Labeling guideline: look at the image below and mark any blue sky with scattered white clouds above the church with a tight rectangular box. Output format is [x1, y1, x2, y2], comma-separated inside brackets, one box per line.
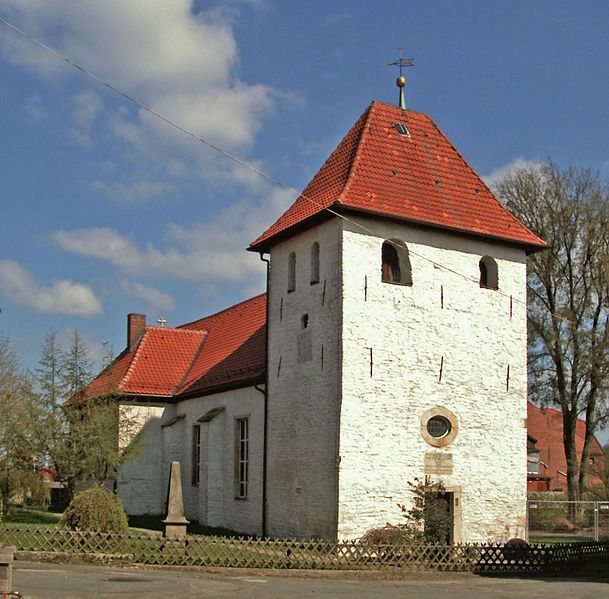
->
[0, 0, 609, 376]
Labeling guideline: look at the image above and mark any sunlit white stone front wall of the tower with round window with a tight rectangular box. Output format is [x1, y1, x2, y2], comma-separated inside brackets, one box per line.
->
[338, 221, 526, 541]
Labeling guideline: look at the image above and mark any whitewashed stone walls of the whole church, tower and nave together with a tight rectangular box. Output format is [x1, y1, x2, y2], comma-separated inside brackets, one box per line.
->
[119, 213, 526, 541]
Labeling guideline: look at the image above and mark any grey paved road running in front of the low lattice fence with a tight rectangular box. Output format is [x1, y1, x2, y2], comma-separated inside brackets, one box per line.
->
[13, 562, 609, 599]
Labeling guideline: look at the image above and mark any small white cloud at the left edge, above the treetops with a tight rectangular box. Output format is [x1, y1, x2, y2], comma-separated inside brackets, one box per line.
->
[0, 260, 102, 316]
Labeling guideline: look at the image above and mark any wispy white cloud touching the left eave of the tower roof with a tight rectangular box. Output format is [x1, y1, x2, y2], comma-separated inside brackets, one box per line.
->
[51, 190, 293, 289]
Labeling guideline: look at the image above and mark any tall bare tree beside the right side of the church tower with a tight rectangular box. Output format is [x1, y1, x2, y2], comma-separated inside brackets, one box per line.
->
[496, 164, 609, 500]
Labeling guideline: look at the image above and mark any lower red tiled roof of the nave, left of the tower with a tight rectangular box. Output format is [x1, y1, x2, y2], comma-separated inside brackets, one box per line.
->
[81, 295, 266, 399]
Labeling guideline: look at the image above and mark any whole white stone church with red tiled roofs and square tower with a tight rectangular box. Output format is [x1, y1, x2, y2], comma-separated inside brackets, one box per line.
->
[85, 94, 545, 542]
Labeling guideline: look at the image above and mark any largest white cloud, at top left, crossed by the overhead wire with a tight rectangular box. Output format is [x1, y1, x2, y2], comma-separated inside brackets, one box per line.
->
[0, 0, 278, 156]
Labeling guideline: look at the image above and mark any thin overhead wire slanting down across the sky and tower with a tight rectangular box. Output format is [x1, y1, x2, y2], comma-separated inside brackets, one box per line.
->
[0, 17, 564, 324]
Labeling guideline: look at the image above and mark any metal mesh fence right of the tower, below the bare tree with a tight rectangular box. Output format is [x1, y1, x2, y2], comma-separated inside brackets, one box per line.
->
[527, 499, 609, 543]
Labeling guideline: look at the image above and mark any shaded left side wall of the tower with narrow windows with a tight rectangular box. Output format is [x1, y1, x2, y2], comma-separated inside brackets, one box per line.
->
[267, 219, 341, 538]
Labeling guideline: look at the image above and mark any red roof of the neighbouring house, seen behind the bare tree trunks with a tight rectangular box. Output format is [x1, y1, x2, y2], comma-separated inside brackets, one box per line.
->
[527, 402, 604, 490]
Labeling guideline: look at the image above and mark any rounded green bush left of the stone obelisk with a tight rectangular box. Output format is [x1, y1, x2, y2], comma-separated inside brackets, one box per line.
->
[62, 487, 129, 533]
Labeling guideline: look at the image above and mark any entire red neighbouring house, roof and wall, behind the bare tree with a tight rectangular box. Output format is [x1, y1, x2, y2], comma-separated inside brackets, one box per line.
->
[527, 402, 604, 492]
